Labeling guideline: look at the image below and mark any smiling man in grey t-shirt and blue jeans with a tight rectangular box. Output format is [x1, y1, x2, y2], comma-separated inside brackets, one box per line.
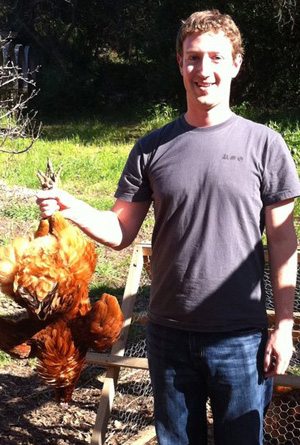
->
[37, 10, 300, 445]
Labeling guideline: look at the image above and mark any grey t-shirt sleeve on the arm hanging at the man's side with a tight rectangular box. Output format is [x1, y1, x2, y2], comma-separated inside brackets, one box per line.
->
[262, 134, 300, 206]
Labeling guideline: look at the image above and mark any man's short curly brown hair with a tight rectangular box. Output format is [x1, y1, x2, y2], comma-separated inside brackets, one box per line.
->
[176, 9, 244, 58]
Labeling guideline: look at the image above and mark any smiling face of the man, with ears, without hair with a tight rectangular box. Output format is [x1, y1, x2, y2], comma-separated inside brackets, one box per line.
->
[177, 31, 242, 110]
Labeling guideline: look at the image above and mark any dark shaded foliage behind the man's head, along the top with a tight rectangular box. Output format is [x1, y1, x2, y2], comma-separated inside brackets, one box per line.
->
[0, 0, 300, 116]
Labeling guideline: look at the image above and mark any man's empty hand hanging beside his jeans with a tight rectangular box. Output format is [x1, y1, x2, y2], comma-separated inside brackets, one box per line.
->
[264, 326, 293, 377]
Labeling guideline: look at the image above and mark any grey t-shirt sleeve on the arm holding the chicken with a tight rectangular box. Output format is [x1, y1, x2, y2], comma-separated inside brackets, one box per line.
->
[115, 141, 152, 202]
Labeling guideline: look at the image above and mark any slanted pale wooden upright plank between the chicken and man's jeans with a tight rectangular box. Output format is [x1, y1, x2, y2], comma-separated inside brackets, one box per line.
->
[91, 245, 143, 445]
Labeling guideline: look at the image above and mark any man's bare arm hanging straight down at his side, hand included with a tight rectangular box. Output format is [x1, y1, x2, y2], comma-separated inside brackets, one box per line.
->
[264, 199, 297, 377]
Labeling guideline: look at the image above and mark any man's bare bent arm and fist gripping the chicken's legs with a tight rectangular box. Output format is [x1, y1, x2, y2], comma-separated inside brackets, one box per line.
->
[36, 189, 151, 250]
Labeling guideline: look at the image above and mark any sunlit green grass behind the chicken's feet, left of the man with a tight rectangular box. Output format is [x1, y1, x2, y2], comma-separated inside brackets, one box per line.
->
[0, 107, 176, 206]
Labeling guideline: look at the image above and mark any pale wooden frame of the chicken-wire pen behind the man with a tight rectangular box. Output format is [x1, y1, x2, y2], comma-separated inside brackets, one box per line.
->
[87, 243, 300, 445]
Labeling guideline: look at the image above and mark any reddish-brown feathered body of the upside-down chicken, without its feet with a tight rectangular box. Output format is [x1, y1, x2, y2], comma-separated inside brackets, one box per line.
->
[0, 170, 123, 402]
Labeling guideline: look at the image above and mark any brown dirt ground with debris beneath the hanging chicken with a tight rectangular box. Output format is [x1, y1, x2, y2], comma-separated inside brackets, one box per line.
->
[0, 361, 106, 445]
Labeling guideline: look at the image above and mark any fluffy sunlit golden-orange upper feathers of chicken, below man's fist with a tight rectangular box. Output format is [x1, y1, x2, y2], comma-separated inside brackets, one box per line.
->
[0, 212, 97, 320]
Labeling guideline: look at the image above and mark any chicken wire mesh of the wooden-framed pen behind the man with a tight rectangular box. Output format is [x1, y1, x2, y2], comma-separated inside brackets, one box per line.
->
[105, 251, 300, 445]
